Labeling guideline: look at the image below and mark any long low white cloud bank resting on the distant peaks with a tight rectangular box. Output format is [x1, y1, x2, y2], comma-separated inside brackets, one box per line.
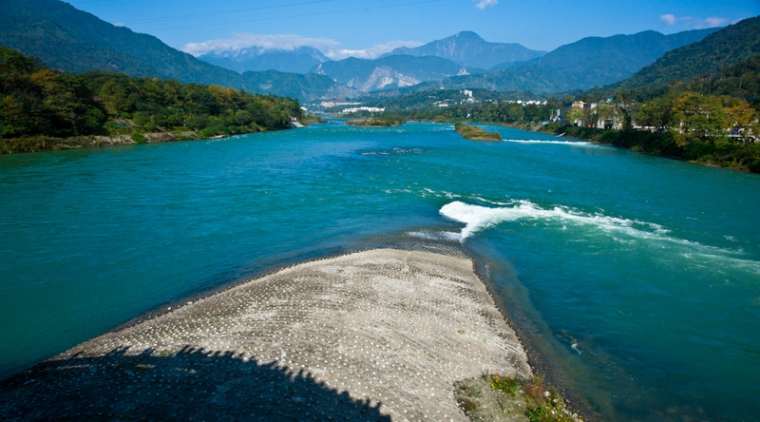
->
[182, 34, 421, 60]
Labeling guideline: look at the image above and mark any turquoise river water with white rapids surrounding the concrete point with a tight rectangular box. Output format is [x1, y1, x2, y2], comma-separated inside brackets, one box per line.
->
[0, 123, 760, 420]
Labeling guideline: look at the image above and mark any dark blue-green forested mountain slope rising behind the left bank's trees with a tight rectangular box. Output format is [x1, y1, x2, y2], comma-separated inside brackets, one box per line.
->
[0, 0, 346, 100]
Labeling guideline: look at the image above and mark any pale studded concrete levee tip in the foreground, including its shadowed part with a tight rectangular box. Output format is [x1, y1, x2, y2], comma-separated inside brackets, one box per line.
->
[0, 249, 530, 421]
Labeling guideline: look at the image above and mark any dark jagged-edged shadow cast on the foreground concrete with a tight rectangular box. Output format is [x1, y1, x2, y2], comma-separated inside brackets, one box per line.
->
[0, 347, 390, 421]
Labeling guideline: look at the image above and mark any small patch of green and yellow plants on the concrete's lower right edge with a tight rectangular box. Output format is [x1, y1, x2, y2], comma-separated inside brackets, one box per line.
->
[454, 375, 583, 422]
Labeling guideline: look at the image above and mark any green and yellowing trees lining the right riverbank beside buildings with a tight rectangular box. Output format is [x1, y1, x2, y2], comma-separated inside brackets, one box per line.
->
[560, 84, 760, 173]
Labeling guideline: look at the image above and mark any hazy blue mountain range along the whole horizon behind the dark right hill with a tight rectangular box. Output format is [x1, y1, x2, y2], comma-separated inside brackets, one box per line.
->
[0, 0, 748, 101]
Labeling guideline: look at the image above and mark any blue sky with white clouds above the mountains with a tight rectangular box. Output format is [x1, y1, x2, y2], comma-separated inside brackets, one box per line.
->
[69, 0, 760, 58]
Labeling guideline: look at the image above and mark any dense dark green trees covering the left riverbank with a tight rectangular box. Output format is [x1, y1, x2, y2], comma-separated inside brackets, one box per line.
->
[0, 47, 302, 153]
